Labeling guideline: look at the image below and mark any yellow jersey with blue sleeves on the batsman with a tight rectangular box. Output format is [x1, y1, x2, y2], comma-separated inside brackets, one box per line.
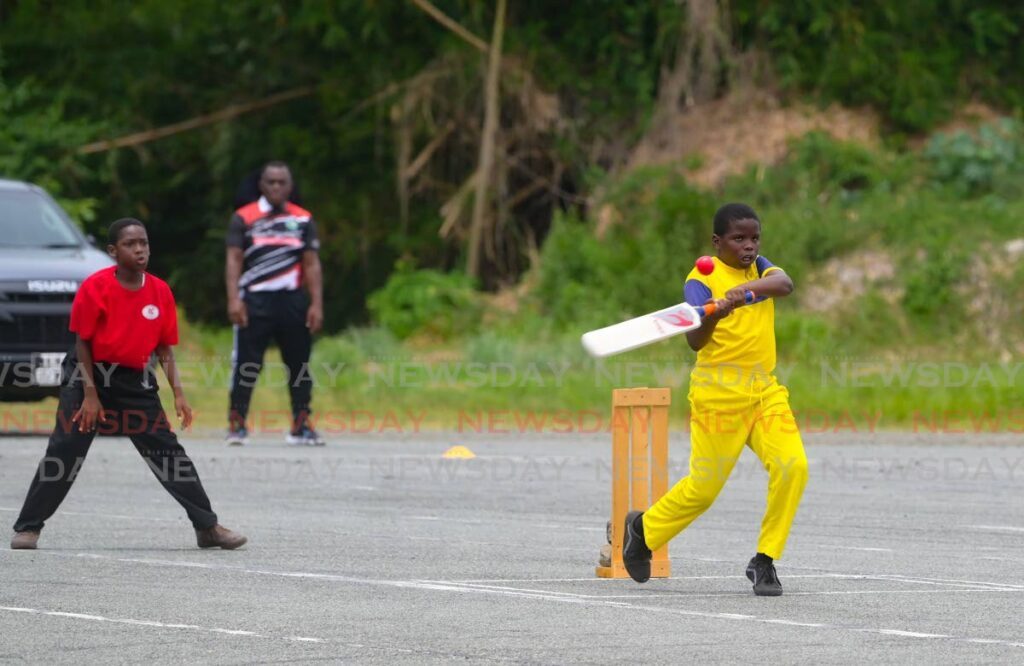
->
[683, 256, 781, 374]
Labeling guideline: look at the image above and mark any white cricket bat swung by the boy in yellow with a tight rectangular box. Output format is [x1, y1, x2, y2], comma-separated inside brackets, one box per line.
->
[582, 291, 756, 358]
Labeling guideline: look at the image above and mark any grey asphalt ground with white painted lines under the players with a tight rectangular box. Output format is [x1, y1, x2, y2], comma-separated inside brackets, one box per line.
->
[0, 433, 1024, 664]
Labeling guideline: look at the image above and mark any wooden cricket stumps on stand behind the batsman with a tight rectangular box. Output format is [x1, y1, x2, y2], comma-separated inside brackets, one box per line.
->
[595, 388, 672, 578]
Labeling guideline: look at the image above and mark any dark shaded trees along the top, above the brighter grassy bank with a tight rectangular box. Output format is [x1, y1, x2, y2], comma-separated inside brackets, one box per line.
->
[0, 0, 1024, 323]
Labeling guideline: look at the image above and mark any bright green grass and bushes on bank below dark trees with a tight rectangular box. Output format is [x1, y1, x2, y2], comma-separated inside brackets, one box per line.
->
[12, 123, 1024, 432]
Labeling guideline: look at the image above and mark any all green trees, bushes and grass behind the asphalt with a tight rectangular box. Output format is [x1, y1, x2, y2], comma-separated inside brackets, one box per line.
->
[0, 0, 1024, 429]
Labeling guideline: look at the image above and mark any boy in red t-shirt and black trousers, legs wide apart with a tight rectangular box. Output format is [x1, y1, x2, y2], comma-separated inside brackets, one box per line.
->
[10, 218, 246, 550]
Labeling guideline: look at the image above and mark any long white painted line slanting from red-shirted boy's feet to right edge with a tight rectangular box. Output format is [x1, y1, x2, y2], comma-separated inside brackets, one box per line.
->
[18, 550, 1024, 648]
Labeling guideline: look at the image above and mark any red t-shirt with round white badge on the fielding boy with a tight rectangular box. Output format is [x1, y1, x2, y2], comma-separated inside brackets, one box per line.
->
[70, 266, 178, 370]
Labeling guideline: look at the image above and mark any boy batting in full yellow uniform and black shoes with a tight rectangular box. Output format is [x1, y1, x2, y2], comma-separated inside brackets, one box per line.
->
[623, 204, 807, 596]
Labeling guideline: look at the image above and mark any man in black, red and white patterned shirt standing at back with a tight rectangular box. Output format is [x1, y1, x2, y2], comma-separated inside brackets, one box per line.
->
[224, 162, 324, 446]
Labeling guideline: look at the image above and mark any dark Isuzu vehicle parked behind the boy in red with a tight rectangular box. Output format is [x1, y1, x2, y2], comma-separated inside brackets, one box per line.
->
[0, 179, 113, 401]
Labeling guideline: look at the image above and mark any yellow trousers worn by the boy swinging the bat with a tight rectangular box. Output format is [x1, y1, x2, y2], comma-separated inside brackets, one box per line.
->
[643, 369, 807, 559]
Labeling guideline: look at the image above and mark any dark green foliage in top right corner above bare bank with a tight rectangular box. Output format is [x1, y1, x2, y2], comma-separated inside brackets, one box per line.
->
[732, 0, 1024, 131]
